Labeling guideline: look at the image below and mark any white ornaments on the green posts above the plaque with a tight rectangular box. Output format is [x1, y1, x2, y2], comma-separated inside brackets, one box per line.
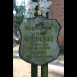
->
[25, 0, 52, 18]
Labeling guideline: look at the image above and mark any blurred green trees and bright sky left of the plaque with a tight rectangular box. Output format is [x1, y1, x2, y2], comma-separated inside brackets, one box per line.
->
[13, 0, 25, 44]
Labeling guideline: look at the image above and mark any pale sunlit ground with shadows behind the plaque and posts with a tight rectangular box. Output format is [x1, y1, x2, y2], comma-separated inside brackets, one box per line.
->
[13, 45, 64, 77]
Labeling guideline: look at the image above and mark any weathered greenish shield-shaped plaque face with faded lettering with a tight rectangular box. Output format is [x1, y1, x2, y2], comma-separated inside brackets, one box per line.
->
[19, 16, 60, 65]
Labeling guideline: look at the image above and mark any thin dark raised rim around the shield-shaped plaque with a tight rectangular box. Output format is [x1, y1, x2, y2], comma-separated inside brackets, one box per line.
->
[18, 16, 61, 65]
